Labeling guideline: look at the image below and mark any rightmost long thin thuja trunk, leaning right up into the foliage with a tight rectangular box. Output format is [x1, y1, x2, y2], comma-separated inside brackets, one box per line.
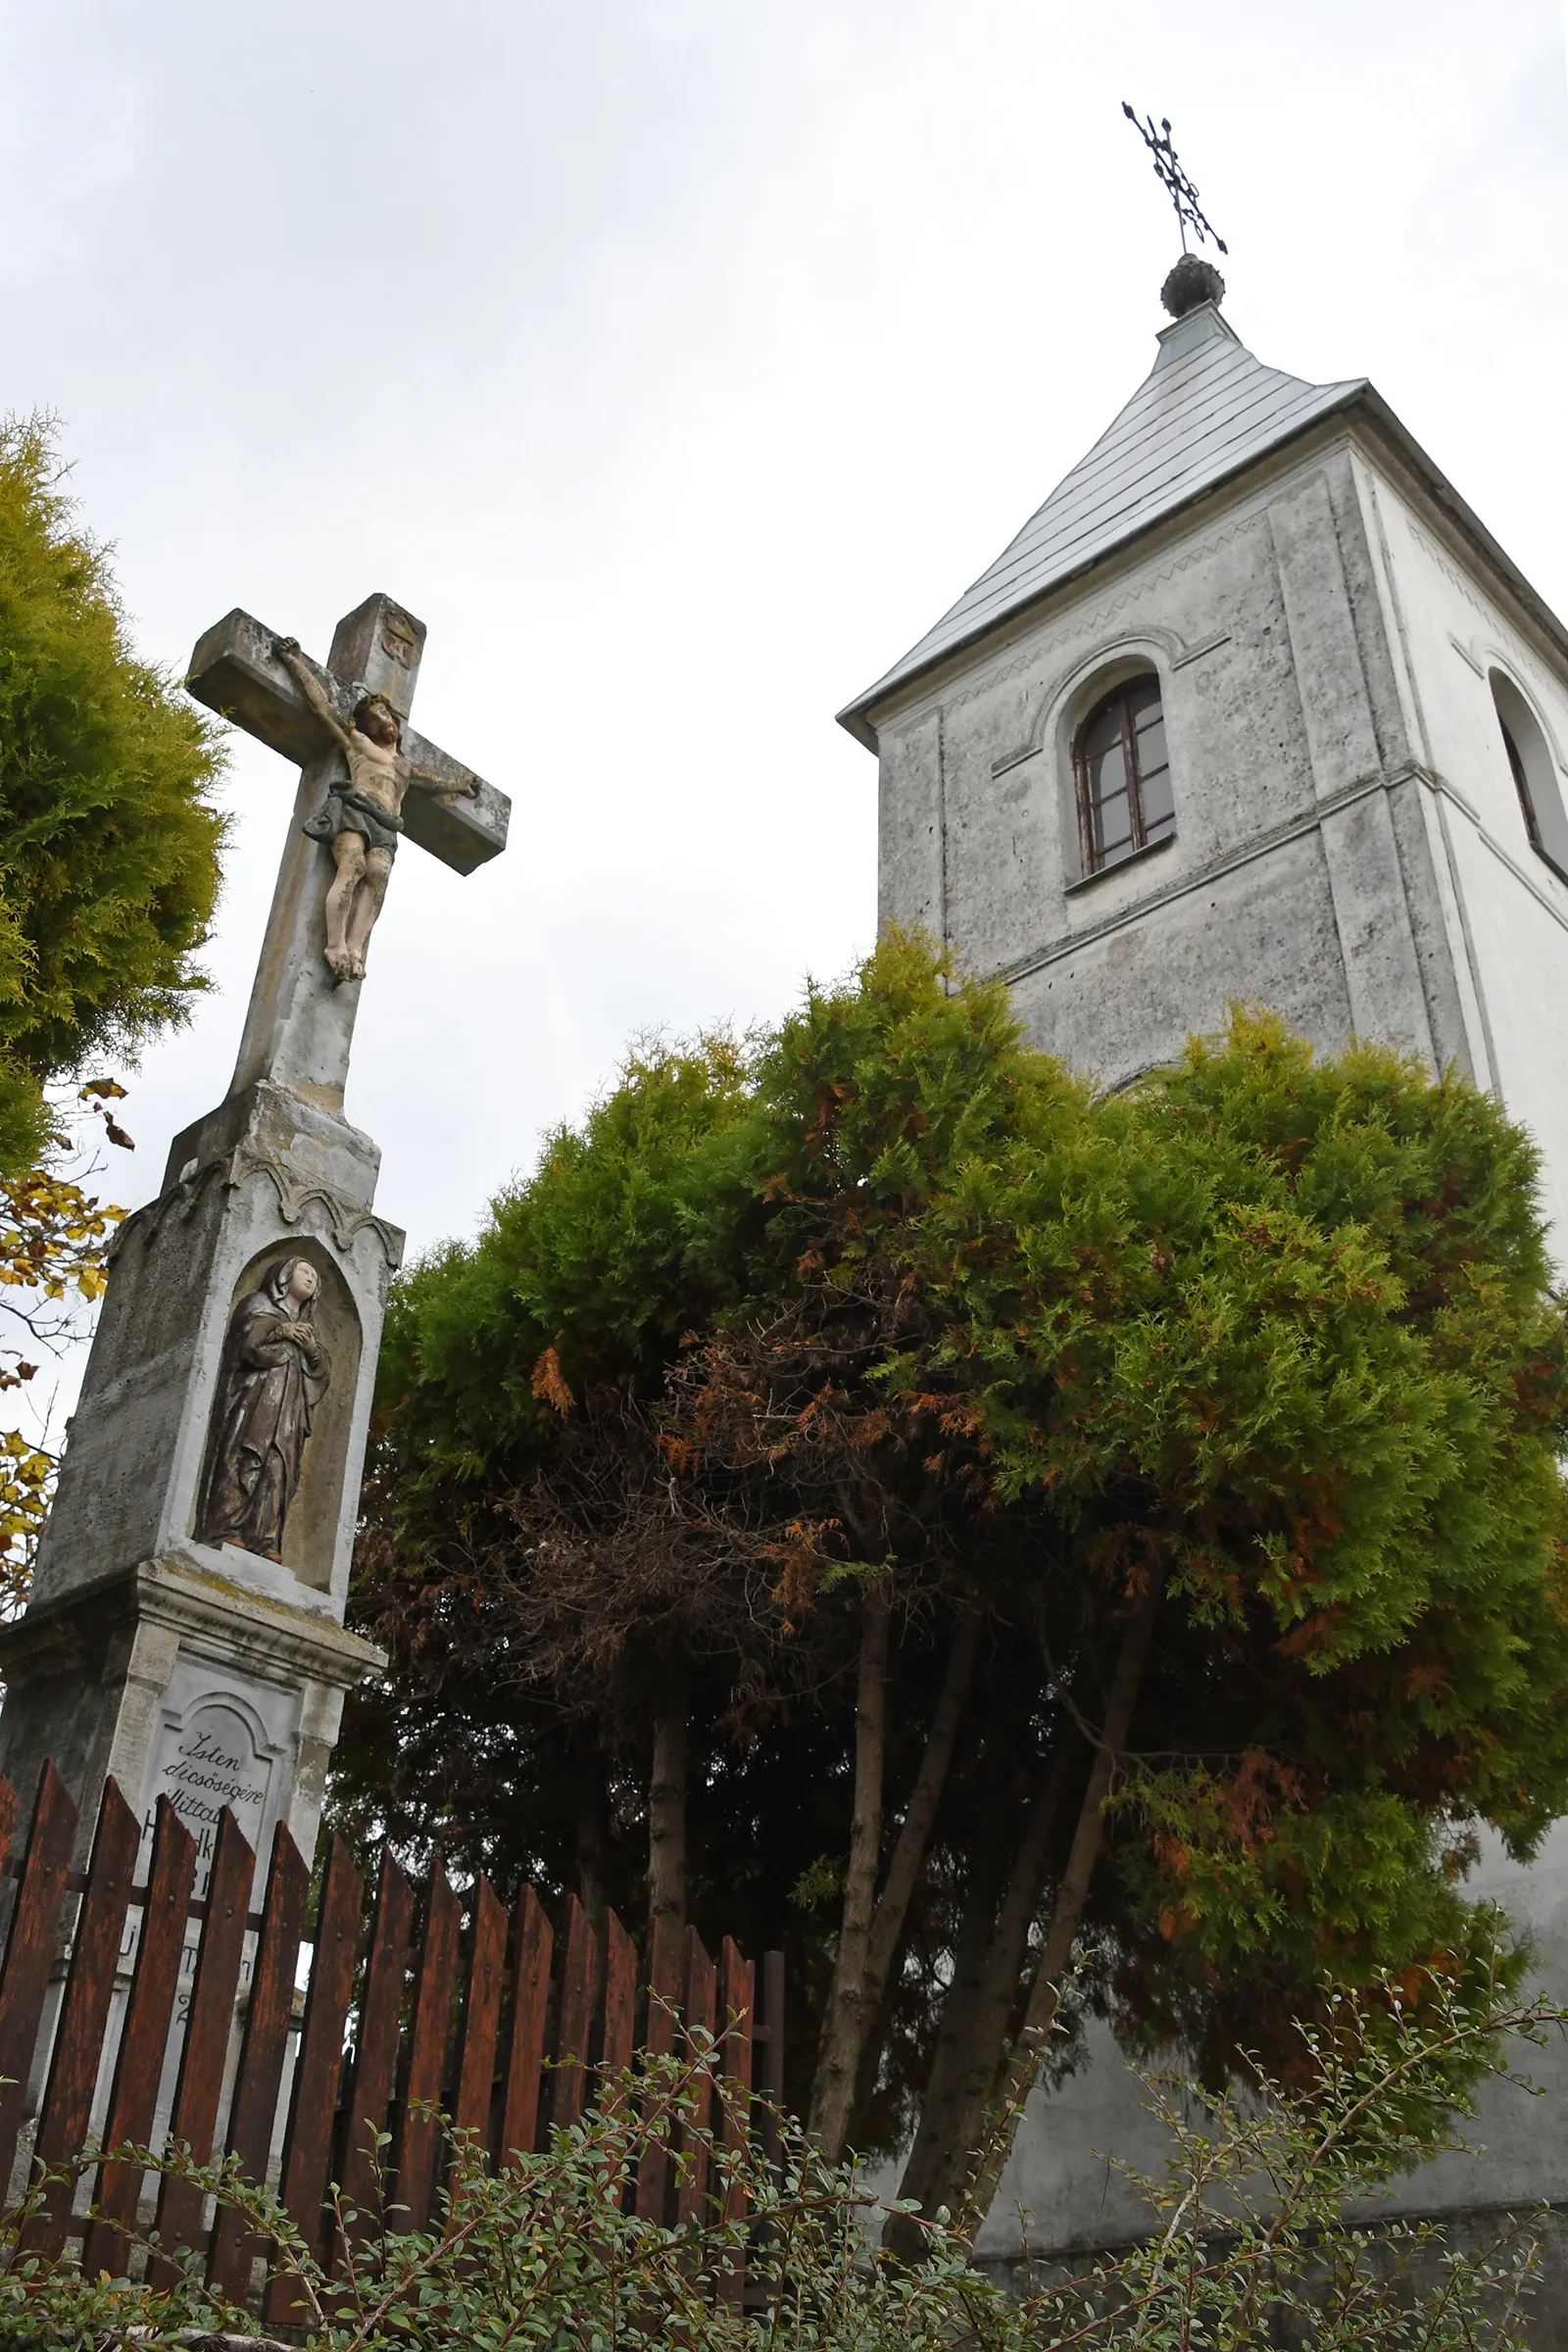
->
[961, 1578, 1159, 2239]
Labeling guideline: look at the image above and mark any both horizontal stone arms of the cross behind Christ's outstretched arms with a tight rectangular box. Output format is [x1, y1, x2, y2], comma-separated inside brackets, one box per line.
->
[186, 612, 513, 875]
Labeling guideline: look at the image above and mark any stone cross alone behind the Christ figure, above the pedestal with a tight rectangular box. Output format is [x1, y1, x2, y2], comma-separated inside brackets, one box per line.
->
[186, 595, 511, 1110]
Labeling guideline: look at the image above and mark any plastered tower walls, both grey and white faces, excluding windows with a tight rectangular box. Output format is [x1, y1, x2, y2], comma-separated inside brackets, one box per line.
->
[872, 404, 1568, 2260]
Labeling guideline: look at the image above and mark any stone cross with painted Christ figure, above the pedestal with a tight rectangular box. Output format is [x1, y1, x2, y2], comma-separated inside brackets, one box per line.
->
[186, 595, 511, 1110]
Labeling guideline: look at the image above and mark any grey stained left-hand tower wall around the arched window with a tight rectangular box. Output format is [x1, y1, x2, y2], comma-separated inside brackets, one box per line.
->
[879, 437, 1504, 1084]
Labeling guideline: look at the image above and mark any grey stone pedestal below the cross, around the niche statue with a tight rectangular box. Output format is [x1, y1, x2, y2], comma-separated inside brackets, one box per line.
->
[0, 1080, 402, 1891]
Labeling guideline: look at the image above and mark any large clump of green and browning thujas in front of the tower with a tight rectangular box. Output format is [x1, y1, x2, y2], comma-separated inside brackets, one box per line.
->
[343, 936, 1568, 2216]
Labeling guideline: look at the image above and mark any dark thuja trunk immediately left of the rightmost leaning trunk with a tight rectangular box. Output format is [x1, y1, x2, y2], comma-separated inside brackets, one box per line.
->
[889, 1736, 1081, 2260]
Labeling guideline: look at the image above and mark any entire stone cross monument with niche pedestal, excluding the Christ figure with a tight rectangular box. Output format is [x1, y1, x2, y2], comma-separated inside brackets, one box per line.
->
[0, 595, 511, 1872]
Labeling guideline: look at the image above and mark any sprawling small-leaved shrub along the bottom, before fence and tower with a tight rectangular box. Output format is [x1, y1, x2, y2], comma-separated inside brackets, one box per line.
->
[0, 1978, 1568, 2352]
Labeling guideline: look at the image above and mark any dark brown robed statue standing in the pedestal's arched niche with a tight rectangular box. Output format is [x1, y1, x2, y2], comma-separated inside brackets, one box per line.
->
[195, 1258, 331, 1559]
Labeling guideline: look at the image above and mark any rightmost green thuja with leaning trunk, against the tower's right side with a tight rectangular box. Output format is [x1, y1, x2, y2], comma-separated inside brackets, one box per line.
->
[883, 1016, 1568, 2238]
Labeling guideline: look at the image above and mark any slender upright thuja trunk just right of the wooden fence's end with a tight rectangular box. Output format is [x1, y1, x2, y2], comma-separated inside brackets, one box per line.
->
[807, 1578, 889, 2159]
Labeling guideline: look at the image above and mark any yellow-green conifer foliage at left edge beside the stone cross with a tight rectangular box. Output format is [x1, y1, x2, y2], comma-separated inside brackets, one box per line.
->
[0, 418, 223, 1174]
